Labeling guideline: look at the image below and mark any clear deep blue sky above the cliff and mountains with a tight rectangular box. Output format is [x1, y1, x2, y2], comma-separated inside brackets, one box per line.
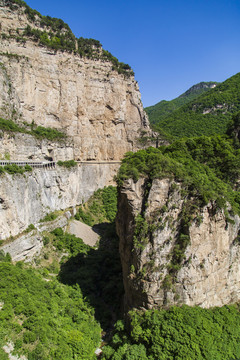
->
[26, 0, 240, 107]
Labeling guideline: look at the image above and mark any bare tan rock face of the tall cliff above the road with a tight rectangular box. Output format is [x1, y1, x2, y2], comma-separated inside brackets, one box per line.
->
[0, 0, 149, 160]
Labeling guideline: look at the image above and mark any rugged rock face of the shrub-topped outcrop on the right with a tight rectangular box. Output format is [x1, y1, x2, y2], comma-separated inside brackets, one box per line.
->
[117, 179, 240, 310]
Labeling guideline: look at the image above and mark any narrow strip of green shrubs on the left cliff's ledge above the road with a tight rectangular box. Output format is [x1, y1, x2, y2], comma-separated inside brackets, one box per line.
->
[0, 118, 66, 140]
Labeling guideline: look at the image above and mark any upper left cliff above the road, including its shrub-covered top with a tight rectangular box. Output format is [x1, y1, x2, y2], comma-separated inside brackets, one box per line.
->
[0, 0, 149, 165]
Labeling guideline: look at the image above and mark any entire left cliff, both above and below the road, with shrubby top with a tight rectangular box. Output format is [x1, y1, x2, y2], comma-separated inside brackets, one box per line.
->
[0, 0, 154, 239]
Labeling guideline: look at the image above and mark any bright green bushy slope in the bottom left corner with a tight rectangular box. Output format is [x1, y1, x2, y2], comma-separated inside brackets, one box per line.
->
[0, 259, 100, 360]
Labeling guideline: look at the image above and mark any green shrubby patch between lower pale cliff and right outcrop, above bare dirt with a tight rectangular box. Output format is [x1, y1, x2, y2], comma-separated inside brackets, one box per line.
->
[75, 186, 117, 226]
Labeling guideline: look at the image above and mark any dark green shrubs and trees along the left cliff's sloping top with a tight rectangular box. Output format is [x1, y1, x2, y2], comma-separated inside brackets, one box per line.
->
[3, 0, 134, 77]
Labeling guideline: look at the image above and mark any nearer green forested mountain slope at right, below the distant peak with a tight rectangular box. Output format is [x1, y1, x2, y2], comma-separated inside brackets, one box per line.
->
[145, 73, 240, 138]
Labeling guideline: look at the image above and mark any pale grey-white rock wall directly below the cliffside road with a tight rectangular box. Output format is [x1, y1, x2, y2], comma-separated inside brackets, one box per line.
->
[0, 164, 119, 239]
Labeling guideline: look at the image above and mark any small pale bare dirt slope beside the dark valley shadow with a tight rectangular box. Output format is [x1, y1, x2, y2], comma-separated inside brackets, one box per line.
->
[68, 220, 99, 246]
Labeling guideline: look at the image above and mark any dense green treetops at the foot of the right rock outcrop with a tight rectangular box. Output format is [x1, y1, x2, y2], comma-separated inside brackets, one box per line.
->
[102, 305, 240, 360]
